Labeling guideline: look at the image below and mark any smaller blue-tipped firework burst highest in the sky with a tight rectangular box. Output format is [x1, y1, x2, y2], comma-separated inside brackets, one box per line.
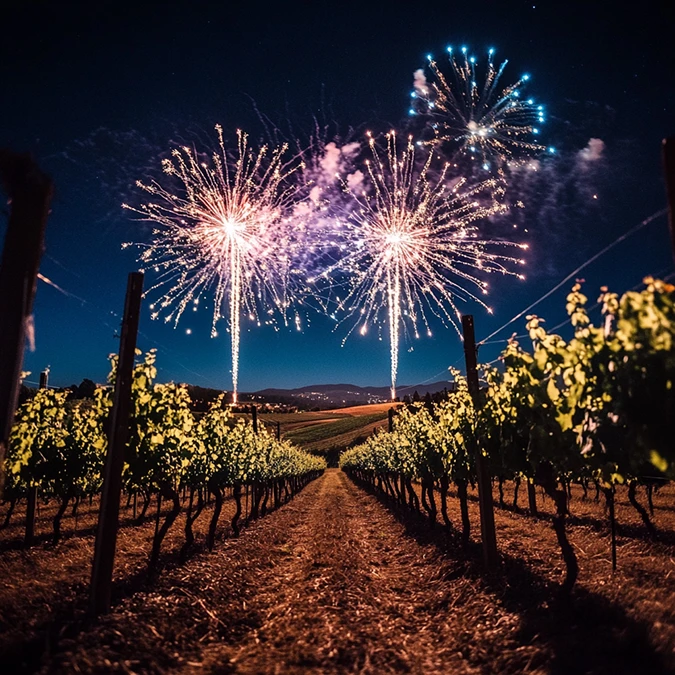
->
[410, 47, 555, 170]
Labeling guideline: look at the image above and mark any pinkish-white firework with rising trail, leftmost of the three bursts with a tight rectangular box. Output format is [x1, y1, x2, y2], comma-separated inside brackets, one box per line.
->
[123, 126, 302, 402]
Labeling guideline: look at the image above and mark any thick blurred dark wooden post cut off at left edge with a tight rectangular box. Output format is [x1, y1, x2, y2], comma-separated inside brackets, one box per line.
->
[0, 150, 54, 496]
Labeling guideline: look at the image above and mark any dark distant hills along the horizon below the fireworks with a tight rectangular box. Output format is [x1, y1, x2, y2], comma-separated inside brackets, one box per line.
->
[251, 381, 454, 408]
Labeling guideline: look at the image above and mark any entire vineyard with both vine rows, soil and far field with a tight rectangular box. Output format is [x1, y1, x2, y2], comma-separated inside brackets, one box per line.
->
[0, 280, 675, 673]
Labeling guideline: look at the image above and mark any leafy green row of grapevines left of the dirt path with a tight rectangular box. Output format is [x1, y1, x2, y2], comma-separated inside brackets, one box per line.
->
[4, 351, 325, 572]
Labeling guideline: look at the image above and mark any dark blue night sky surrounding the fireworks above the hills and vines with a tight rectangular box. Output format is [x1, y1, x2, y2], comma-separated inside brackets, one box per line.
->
[0, 0, 675, 391]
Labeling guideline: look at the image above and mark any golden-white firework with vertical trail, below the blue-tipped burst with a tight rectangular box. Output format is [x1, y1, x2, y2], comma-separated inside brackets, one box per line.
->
[310, 131, 527, 399]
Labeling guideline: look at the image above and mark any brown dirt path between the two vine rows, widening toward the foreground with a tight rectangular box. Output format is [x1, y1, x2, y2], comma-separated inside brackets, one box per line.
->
[42, 470, 672, 675]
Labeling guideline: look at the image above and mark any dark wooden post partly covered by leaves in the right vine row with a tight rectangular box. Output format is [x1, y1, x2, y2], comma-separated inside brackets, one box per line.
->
[462, 314, 498, 570]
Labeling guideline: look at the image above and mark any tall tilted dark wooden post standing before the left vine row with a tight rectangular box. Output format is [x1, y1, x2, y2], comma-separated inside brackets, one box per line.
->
[90, 272, 143, 614]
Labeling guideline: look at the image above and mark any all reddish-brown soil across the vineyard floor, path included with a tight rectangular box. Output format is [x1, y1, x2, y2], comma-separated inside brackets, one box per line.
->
[0, 469, 675, 674]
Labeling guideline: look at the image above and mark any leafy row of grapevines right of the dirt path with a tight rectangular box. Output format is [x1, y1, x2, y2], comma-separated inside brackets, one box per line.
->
[341, 279, 675, 590]
